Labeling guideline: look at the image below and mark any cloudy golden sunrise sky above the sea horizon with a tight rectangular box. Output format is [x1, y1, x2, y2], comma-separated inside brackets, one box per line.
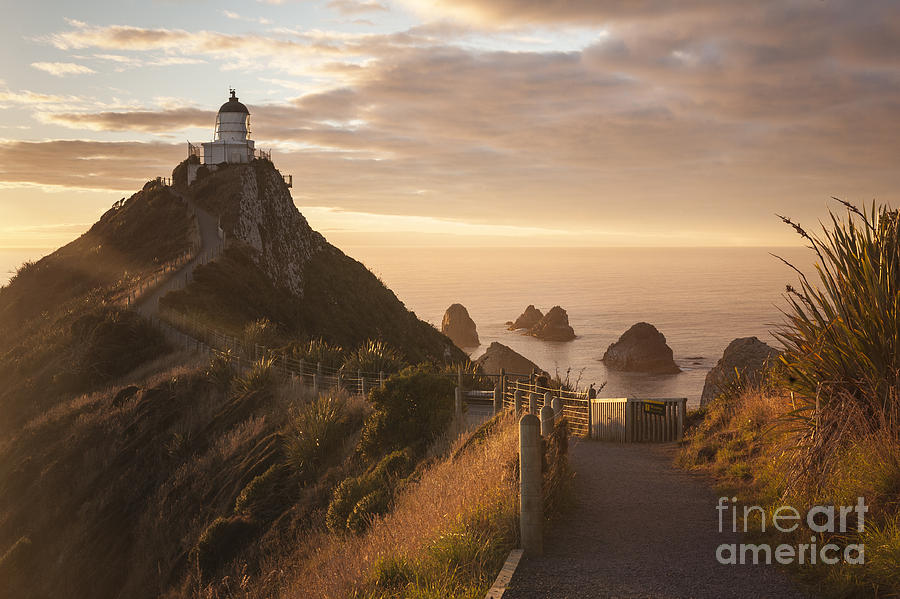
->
[0, 0, 900, 247]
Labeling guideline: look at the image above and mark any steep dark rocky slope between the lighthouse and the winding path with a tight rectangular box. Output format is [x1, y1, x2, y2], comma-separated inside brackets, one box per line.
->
[162, 160, 463, 362]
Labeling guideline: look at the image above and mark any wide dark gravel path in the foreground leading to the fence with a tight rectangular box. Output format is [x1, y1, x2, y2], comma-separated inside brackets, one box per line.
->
[503, 441, 806, 599]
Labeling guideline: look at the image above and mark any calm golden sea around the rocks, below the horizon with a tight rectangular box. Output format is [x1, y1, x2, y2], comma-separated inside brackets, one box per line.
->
[0, 246, 812, 405]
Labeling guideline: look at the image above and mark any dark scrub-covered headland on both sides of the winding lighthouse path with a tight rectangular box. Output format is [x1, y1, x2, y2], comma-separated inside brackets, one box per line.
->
[0, 161, 472, 597]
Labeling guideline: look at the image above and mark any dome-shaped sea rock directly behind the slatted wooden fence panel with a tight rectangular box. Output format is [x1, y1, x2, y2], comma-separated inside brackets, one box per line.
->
[602, 322, 681, 374]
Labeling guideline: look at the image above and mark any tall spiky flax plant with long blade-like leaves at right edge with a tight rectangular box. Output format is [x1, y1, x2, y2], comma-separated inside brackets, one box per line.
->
[775, 198, 900, 411]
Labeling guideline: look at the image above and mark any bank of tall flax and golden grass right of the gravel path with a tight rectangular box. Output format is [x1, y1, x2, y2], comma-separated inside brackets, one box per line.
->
[680, 204, 900, 597]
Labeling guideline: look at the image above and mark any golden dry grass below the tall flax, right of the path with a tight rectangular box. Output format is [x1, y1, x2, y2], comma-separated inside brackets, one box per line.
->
[678, 389, 900, 597]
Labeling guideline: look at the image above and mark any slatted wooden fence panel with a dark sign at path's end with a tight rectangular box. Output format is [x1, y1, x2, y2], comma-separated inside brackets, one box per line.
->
[591, 398, 687, 443]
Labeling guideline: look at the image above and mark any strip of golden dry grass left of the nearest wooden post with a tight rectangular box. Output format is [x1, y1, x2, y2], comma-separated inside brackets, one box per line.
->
[281, 416, 517, 598]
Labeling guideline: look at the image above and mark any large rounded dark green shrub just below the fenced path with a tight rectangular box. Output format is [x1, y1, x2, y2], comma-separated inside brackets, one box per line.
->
[359, 366, 453, 459]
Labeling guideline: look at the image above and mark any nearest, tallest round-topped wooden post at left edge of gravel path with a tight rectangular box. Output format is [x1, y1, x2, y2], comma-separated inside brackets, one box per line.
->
[519, 414, 544, 556]
